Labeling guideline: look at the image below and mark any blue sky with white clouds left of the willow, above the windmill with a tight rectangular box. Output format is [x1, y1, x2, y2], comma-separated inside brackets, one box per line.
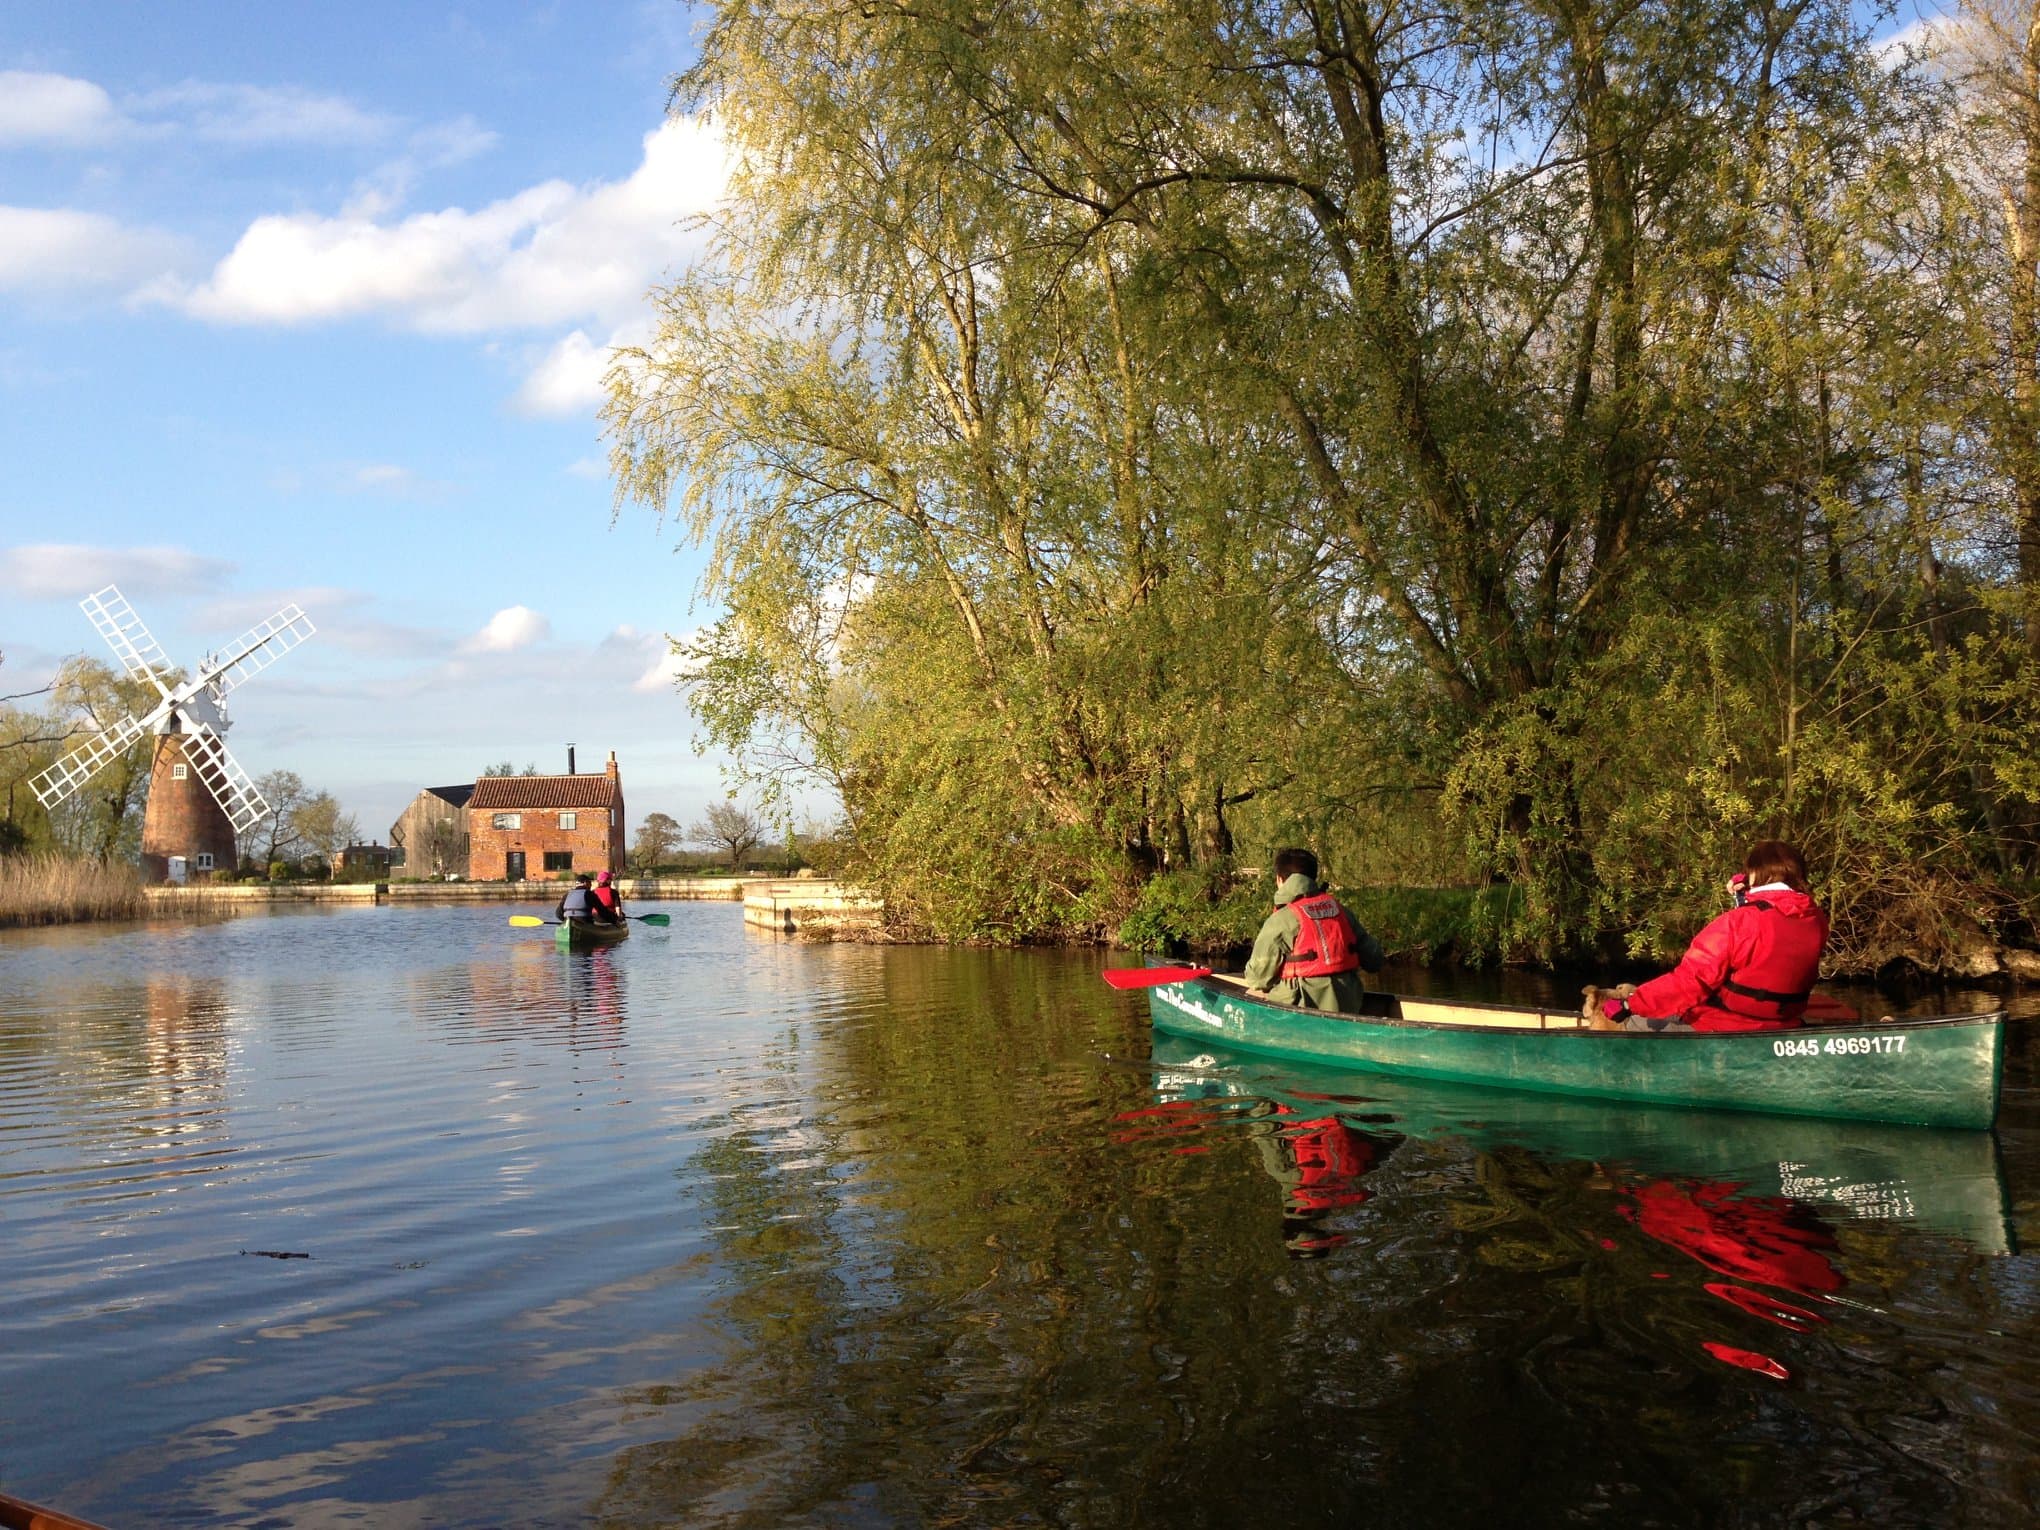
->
[0, 0, 742, 834]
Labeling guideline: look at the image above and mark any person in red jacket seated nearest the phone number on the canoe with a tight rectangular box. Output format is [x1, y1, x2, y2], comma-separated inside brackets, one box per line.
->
[1599, 838, 1828, 1030]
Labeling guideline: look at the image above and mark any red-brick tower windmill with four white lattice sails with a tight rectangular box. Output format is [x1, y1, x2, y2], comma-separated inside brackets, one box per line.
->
[29, 585, 316, 881]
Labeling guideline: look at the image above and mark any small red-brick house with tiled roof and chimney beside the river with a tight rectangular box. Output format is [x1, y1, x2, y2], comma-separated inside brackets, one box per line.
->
[467, 749, 624, 881]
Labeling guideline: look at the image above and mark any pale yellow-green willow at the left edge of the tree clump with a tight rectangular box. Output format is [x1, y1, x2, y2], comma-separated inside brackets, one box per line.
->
[608, 14, 1371, 936]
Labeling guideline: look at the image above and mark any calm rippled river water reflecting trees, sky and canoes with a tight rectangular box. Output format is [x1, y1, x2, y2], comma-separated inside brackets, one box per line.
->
[0, 904, 2040, 1528]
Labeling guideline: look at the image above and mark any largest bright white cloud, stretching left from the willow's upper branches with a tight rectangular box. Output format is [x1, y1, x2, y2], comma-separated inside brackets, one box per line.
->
[184, 118, 726, 334]
